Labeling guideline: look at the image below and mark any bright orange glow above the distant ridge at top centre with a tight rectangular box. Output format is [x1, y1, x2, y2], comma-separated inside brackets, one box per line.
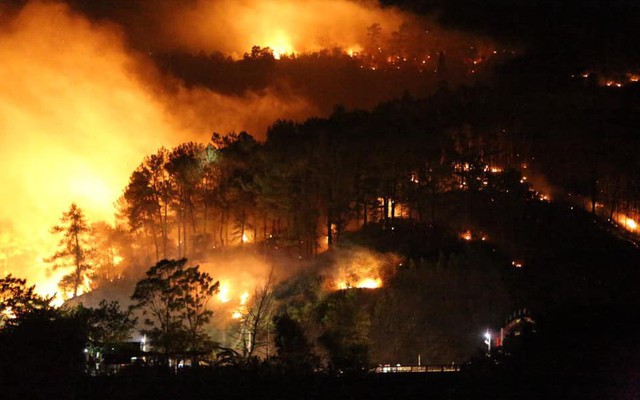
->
[158, 0, 411, 59]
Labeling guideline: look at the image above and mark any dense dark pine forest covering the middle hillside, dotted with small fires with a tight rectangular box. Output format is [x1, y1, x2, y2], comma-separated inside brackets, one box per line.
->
[11, 70, 638, 367]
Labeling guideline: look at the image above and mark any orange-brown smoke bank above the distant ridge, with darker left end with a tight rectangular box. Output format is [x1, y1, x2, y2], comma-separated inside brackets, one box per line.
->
[63, 0, 404, 58]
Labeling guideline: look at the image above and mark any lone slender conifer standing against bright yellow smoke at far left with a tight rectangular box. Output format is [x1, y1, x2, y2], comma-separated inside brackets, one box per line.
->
[45, 203, 93, 298]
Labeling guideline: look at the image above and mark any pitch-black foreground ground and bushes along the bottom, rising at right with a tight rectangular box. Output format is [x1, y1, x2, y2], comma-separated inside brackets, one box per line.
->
[5, 304, 640, 400]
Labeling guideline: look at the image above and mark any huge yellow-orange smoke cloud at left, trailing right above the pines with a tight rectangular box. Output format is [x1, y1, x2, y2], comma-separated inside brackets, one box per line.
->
[0, 1, 316, 291]
